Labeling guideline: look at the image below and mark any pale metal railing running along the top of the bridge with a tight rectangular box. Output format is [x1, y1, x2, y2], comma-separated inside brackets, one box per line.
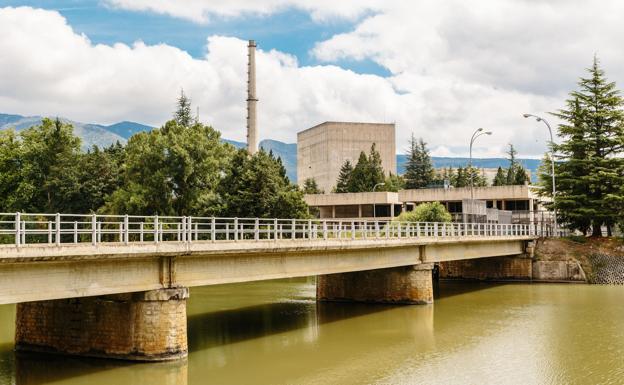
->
[0, 213, 535, 247]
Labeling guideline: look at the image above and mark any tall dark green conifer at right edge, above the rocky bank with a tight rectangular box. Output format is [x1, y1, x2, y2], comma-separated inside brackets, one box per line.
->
[543, 57, 624, 236]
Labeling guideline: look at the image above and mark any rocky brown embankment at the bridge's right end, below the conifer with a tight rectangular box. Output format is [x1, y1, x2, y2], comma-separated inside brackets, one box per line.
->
[533, 237, 624, 285]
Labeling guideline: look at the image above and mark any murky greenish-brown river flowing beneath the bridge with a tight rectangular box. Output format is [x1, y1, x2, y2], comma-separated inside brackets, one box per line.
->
[0, 278, 624, 385]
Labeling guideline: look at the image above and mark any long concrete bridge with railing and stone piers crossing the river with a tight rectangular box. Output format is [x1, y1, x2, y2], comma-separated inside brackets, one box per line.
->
[0, 213, 536, 360]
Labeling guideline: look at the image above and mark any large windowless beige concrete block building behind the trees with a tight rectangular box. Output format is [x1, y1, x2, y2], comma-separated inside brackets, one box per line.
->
[297, 122, 397, 193]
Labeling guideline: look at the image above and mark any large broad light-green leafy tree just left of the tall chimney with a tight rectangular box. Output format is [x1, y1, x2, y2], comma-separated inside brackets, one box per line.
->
[103, 120, 234, 216]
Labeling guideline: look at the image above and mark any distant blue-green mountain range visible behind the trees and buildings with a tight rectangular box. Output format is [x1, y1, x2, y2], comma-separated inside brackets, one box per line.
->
[0, 113, 540, 182]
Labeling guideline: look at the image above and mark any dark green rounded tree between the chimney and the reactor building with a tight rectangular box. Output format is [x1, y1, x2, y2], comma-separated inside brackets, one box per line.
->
[219, 149, 308, 218]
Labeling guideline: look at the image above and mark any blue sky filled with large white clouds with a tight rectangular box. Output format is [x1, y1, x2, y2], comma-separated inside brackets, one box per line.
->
[0, 0, 624, 157]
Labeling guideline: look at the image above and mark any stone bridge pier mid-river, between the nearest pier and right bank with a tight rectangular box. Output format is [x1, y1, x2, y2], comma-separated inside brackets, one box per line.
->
[316, 263, 433, 304]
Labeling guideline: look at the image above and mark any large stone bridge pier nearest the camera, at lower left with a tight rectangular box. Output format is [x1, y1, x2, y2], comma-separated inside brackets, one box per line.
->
[15, 287, 188, 361]
